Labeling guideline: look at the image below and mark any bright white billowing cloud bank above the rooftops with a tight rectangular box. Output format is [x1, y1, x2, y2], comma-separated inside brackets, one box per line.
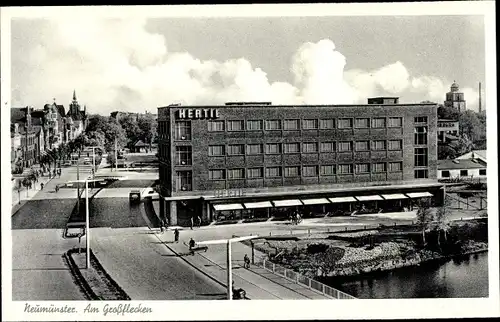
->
[13, 16, 477, 114]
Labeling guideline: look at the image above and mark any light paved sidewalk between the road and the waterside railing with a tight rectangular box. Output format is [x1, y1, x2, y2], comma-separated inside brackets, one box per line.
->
[156, 234, 329, 300]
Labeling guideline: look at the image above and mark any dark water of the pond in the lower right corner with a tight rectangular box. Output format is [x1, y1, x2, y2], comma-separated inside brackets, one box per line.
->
[331, 252, 488, 299]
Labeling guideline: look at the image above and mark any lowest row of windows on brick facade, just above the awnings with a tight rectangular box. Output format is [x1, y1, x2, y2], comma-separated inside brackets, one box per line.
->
[208, 161, 403, 180]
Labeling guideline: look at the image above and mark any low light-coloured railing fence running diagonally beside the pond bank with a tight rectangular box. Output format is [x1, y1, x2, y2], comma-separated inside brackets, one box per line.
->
[255, 259, 356, 300]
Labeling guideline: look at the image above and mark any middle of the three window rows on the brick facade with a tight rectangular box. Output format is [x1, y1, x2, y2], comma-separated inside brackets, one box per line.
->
[208, 140, 403, 156]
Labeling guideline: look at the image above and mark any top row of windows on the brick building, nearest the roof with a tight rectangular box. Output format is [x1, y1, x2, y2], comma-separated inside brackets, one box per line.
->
[208, 117, 403, 132]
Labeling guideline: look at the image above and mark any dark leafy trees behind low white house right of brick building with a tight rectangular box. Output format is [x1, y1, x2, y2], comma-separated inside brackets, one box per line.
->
[437, 105, 486, 160]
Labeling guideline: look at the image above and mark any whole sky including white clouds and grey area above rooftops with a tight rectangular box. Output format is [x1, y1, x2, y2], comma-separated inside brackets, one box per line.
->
[11, 15, 485, 115]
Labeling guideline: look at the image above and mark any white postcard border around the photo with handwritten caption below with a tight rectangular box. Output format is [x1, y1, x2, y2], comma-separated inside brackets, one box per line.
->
[1, 1, 500, 321]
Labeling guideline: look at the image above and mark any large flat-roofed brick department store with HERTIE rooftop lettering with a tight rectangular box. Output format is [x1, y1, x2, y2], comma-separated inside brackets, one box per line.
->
[158, 98, 444, 225]
